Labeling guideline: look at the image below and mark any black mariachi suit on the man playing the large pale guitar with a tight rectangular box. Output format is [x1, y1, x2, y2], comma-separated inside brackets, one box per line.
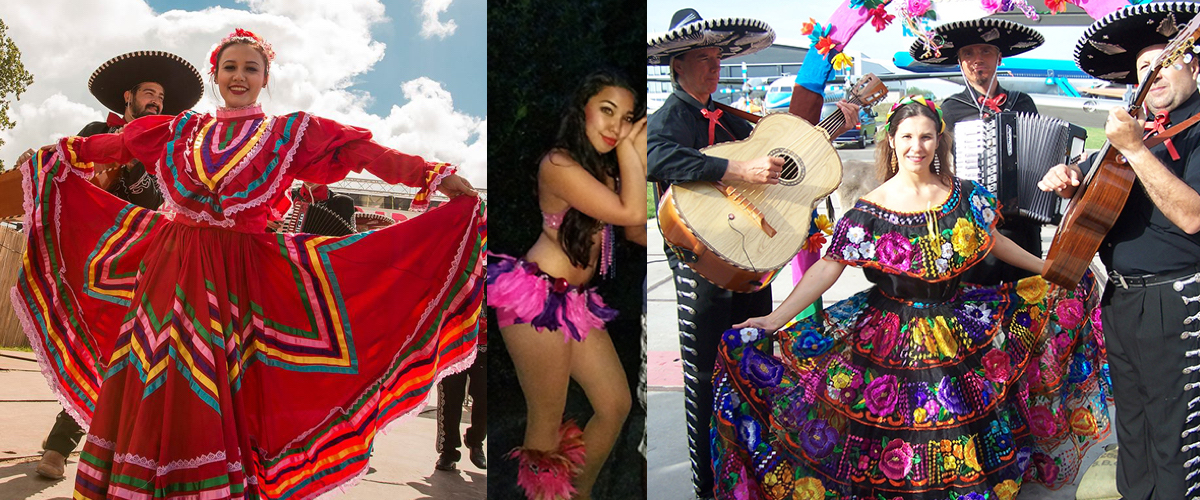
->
[647, 90, 772, 498]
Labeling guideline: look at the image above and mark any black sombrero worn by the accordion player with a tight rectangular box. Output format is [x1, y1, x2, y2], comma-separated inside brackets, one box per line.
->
[908, 19, 1045, 66]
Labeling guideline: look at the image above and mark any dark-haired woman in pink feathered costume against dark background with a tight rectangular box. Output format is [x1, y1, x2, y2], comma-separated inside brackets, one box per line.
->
[487, 71, 646, 500]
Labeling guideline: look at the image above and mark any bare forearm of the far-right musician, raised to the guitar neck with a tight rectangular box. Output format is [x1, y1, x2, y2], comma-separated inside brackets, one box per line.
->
[1104, 108, 1200, 234]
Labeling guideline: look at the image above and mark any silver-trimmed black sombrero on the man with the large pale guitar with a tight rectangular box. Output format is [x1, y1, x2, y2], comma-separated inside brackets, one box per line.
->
[646, 8, 775, 65]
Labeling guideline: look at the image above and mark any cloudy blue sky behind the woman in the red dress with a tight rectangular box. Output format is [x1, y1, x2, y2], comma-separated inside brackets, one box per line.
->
[0, 0, 487, 187]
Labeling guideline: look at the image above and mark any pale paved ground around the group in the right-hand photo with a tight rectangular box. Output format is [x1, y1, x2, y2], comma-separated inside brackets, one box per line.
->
[646, 143, 1116, 500]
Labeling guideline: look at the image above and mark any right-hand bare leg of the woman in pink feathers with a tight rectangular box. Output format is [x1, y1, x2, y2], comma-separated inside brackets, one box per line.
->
[570, 330, 631, 500]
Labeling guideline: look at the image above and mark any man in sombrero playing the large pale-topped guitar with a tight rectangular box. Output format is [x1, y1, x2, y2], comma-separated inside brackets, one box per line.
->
[647, 8, 858, 499]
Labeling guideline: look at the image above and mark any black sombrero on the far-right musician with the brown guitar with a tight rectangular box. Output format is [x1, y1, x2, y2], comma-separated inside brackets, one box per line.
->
[1075, 1, 1200, 84]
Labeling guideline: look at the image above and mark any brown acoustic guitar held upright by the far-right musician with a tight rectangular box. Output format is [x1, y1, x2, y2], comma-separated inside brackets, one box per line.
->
[1042, 16, 1200, 289]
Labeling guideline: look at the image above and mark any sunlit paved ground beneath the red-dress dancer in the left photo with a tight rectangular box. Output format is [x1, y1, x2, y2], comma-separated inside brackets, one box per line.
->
[0, 350, 487, 500]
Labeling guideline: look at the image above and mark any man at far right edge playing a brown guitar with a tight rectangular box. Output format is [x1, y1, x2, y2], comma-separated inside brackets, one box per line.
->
[1038, 2, 1200, 500]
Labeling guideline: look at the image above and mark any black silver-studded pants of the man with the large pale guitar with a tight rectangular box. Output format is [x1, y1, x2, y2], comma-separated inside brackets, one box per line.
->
[667, 256, 772, 498]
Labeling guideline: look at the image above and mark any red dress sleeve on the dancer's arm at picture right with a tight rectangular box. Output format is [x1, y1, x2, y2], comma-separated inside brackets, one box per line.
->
[295, 115, 457, 211]
